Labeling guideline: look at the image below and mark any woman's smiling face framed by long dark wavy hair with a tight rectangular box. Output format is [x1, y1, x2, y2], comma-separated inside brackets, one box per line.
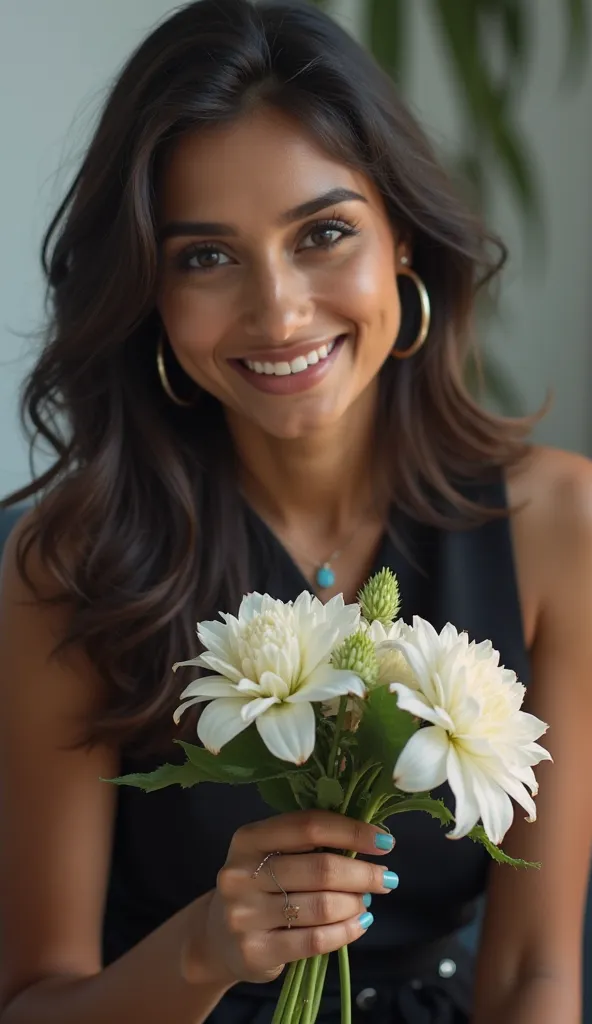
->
[158, 110, 407, 438]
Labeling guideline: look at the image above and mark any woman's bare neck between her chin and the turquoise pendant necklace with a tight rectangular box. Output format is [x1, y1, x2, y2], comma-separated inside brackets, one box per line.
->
[228, 387, 381, 538]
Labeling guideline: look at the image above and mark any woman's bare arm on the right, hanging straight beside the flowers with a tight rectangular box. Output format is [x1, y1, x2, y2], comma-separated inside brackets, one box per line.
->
[474, 450, 592, 1024]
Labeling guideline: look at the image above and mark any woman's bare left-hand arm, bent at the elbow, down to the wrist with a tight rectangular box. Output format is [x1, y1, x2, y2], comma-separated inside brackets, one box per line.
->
[0, 537, 230, 1024]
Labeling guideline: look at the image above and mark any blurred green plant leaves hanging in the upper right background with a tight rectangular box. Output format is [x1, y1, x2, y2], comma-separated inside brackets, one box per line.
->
[311, 0, 592, 415]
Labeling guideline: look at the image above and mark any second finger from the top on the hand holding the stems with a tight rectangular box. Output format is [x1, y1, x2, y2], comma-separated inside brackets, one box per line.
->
[250, 853, 393, 896]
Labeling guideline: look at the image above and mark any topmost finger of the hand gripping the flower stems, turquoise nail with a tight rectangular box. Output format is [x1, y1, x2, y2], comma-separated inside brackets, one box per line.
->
[229, 810, 394, 862]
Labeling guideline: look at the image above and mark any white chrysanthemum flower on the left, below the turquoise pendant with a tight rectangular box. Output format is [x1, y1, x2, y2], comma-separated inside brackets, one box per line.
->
[174, 592, 366, 764]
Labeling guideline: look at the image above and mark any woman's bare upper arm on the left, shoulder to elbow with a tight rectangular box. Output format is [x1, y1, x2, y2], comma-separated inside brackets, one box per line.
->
[0, 513, 118, 1012]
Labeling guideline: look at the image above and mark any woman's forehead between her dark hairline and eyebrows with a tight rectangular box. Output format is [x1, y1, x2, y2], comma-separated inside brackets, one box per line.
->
[159, 110, 381, 223]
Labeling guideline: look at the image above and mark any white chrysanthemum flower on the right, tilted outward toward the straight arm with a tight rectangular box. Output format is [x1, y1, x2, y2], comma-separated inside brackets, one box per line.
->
[390, 616, 551, 844]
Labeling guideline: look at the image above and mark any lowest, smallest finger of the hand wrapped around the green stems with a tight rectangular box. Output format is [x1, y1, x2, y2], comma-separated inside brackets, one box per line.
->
[263, 910, 374, 966]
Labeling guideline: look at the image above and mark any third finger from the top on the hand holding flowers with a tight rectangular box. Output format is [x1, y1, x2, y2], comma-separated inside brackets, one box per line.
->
[241, 892, 370, 932]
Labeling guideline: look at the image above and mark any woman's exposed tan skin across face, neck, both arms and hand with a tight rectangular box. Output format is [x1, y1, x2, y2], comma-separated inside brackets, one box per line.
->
[0, 112, 592, 1024]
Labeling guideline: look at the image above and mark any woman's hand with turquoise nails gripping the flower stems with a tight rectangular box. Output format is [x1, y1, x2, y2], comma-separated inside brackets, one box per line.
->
[204, 811, 398, 982]
